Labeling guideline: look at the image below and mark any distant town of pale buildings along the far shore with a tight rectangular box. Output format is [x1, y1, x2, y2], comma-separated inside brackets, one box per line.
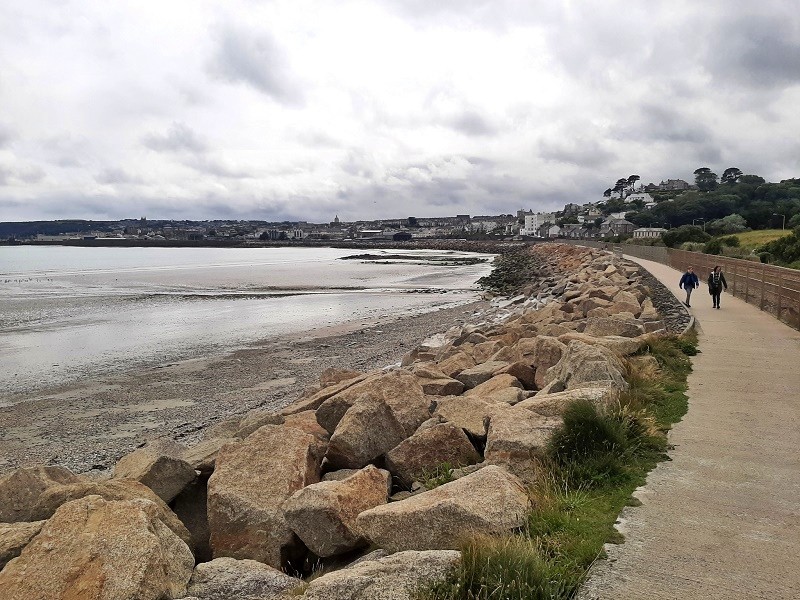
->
[0, 180, 692, 243]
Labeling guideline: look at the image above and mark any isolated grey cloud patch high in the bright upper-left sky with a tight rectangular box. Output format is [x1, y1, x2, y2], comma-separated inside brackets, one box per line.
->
[208, 27, 302, 105]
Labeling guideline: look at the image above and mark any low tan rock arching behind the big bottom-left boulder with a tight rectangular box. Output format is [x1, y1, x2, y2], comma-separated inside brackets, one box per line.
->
[31, 479, 192, 548]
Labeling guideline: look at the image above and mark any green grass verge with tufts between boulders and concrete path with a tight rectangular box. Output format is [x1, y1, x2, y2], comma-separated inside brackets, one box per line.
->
[418, 332, 697, 600]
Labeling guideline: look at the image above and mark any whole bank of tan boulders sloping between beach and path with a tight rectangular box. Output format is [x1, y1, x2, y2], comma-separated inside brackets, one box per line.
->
[0, 244, 689, 600]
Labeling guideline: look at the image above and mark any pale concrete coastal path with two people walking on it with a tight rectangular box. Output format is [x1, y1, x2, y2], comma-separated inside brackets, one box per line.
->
[579, 257, 800, 600]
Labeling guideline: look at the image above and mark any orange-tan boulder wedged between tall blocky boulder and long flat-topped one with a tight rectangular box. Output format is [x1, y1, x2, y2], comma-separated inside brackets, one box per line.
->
[283, 465, 389, 558]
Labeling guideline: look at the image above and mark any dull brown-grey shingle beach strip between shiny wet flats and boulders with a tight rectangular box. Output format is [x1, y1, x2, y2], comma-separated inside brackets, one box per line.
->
[0, 302, 488, 474]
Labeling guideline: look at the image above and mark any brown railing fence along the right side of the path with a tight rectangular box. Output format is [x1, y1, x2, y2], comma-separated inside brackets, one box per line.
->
[615, 245, 800, 329]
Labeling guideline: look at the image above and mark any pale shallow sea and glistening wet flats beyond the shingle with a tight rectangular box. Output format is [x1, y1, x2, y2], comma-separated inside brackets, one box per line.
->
[0, 245, 492, 396]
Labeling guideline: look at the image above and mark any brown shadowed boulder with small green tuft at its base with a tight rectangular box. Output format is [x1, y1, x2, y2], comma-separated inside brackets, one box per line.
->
[386, 423, 480, 486]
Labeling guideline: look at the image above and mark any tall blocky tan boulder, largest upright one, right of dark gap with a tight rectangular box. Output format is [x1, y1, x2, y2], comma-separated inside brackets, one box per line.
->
[208, 425, 323, 568]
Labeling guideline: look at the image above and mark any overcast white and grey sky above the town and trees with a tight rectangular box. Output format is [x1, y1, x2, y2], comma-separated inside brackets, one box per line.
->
[0, 0, 800, 221]
